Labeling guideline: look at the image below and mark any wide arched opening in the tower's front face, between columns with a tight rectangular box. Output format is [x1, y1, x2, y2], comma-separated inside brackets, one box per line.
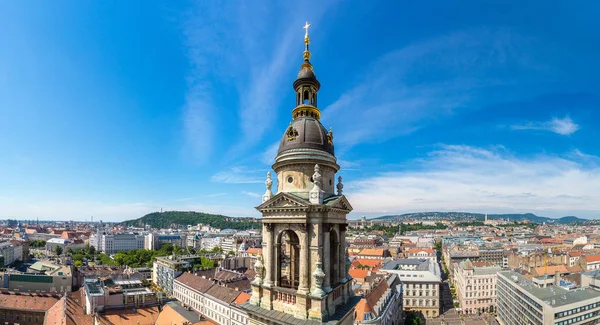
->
[276, 230, 300, 289]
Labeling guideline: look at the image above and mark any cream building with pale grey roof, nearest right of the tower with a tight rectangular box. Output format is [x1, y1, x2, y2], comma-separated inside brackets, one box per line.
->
[380, 259, 442, 318]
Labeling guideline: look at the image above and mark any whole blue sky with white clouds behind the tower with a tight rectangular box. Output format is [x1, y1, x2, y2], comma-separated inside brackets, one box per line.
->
[0, 1, 600, 220]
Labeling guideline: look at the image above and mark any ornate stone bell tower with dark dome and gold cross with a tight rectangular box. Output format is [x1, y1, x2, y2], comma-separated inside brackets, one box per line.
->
[243, 23, 356, 324]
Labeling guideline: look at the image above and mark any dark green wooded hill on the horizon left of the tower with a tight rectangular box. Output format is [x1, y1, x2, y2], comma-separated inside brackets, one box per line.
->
[121, 211, 260, 230]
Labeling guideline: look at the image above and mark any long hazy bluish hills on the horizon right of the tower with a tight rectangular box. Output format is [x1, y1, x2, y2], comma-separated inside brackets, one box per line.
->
[374, 212, 589, 224]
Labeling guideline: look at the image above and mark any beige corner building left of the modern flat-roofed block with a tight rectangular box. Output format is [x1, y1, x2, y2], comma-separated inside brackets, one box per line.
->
[454, 260, 502, 314]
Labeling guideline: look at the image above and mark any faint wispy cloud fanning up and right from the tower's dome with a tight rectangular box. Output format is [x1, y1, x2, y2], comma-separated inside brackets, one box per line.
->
[323, 29, 548, 147]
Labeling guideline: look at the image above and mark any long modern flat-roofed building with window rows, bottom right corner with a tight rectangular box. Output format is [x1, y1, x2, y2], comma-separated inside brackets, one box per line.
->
[497, 271, 600, 325]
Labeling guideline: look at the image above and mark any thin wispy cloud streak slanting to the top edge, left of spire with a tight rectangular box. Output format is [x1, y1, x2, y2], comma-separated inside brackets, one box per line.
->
[229, 3, 328, 156]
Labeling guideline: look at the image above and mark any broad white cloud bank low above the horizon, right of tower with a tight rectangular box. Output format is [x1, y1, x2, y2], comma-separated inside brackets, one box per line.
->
[345, 146, 600, 217]
